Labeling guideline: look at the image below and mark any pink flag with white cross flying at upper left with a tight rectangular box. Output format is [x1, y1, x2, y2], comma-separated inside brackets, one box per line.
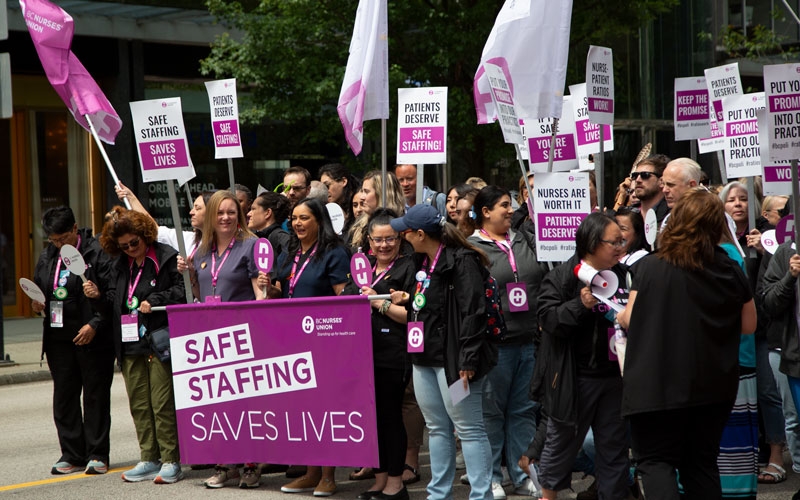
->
[19, 0, 122, 144]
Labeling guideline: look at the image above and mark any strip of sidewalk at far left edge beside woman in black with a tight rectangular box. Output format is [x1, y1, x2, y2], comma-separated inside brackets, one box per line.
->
[0, 317, 51, 385]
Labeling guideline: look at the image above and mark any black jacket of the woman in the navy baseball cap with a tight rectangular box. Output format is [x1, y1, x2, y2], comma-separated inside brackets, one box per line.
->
[407, 247, 497, 384]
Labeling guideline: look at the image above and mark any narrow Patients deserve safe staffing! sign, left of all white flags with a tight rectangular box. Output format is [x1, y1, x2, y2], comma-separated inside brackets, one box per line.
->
[206, 78, 244, 159]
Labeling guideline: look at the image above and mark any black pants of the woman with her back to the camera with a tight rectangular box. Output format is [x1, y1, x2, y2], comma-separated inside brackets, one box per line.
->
[630, 401, 733, 500]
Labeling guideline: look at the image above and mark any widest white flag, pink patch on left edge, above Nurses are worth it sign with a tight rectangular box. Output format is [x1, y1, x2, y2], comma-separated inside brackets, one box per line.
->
[473, 0, 572, 123]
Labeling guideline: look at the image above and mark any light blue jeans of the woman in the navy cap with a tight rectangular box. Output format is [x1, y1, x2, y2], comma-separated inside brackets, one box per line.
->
[414, 365, 494, 500]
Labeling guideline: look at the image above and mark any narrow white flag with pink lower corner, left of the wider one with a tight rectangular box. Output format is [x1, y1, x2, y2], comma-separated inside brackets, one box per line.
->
[337, 0, 389, 154]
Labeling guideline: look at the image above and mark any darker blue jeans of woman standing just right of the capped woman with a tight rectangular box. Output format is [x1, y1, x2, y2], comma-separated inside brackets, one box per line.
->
[483, 343, 536, 486]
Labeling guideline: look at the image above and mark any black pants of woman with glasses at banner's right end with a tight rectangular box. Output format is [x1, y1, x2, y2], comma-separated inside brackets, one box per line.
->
[375, 367, 410, 476]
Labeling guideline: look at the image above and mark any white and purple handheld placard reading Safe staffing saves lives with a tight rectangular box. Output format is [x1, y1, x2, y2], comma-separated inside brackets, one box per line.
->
[130, 97, 195, 182]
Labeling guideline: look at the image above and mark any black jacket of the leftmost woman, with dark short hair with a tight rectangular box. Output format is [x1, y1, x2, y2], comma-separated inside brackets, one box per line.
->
[33, 228, 112, 352]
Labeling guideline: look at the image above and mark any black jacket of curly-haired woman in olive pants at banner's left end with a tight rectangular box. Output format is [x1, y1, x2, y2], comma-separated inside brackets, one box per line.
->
[102, 242, 186, 363]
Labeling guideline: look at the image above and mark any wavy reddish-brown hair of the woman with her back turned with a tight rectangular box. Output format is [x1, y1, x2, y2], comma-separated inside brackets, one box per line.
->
[657, 187, 728, 271]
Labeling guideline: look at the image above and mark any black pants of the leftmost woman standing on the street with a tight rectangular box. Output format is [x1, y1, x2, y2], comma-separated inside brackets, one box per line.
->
[45, 340, 114, 466]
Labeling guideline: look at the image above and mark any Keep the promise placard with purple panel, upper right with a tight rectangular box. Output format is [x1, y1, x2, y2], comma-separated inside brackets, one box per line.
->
[673, 76, 711, 141]
